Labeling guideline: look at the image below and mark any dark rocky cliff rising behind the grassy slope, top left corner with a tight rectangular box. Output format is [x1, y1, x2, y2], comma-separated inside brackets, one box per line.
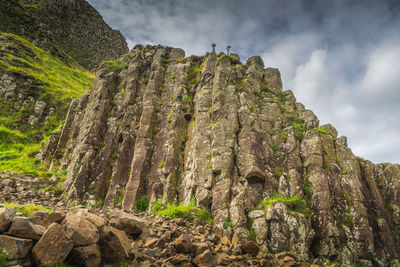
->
[0, 0, 128, 71]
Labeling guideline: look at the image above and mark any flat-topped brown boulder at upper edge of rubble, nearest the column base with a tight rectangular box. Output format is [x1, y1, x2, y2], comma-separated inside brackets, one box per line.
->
[110, 211, 146, 235]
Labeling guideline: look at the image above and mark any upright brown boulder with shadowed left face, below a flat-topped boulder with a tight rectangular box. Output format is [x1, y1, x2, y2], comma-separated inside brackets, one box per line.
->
[99, 226, 131, 261]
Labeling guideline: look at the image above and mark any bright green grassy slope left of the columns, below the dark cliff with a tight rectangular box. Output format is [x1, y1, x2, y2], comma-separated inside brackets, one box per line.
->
[0, 33, 94, 176]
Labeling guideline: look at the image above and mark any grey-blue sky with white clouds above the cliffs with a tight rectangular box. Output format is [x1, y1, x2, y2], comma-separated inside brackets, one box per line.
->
[89, 0, 400, 163]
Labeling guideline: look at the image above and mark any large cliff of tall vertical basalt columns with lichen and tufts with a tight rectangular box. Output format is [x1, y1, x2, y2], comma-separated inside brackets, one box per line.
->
[39, 46, 400, 266]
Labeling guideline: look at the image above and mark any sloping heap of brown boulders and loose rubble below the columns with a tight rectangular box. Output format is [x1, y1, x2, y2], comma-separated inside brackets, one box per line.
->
[0, 204, 318, 267]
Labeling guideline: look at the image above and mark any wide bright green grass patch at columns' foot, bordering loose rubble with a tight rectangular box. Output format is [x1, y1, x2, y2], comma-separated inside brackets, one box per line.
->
[155, 199, 214, 223]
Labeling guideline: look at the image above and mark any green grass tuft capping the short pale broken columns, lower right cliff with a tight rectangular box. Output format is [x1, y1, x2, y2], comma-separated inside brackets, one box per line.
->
[261, 194, 312, 218]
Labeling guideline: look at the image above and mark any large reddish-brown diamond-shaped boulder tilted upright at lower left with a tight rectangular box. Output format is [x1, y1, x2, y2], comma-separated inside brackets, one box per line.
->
[32, 223, 73, 267]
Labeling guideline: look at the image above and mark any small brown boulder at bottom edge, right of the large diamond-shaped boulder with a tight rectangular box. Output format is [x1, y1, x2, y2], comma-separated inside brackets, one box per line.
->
[69, 244, 101, 267]
